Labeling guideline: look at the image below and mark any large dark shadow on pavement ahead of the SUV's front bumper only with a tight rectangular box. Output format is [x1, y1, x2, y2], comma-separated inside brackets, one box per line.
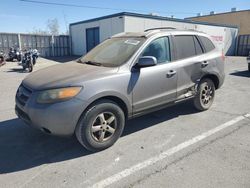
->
[0, 119, 90, 174]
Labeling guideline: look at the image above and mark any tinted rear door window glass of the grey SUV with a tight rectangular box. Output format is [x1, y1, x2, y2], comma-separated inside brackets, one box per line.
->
[175, 35, 196, 59]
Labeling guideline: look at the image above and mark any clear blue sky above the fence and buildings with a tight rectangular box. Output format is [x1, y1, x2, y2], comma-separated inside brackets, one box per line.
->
[0, 0, 250, 33]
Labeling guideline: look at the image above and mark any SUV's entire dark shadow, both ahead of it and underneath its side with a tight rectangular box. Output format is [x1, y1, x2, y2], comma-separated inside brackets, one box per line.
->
[0, 103, 197, 174]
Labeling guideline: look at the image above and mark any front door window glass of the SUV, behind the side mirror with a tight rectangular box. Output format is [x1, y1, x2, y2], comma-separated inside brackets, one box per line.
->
[142, 37, 170, 63]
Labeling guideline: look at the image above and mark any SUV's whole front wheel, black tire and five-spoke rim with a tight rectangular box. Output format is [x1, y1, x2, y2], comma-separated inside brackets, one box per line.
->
[75, 100, 125, 152]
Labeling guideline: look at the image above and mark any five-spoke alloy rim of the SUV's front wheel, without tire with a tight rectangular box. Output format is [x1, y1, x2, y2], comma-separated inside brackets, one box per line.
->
[91, 112, 117, 142]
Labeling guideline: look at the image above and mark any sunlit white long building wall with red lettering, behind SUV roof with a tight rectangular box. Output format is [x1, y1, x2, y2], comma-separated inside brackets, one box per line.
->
[125, 16, 238, 55]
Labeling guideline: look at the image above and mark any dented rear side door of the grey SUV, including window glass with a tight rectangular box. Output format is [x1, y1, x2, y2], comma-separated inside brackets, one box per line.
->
[174, 35, 204, 98]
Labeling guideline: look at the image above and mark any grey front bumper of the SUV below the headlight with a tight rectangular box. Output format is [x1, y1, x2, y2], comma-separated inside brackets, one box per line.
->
[15, 84, 87, 136]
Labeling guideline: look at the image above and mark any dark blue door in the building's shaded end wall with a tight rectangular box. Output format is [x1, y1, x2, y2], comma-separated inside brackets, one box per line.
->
[86, 27, 100, 52]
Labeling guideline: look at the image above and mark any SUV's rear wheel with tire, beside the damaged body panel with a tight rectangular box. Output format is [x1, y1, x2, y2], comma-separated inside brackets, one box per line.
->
[194, 79, 215, 111]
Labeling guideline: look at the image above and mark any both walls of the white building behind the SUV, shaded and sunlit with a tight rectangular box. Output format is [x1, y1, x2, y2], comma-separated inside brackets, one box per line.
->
[70, 15, 238, 55]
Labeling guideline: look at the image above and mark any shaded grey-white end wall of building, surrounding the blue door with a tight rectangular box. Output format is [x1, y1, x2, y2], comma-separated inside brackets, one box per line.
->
[70, 17, 124, 55]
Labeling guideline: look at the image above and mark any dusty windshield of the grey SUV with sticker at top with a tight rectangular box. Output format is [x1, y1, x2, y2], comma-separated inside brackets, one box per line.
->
[80, 37, 145, 67]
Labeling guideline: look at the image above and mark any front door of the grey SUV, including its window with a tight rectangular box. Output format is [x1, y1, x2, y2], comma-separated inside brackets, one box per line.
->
[131, 37, 177, 113]
